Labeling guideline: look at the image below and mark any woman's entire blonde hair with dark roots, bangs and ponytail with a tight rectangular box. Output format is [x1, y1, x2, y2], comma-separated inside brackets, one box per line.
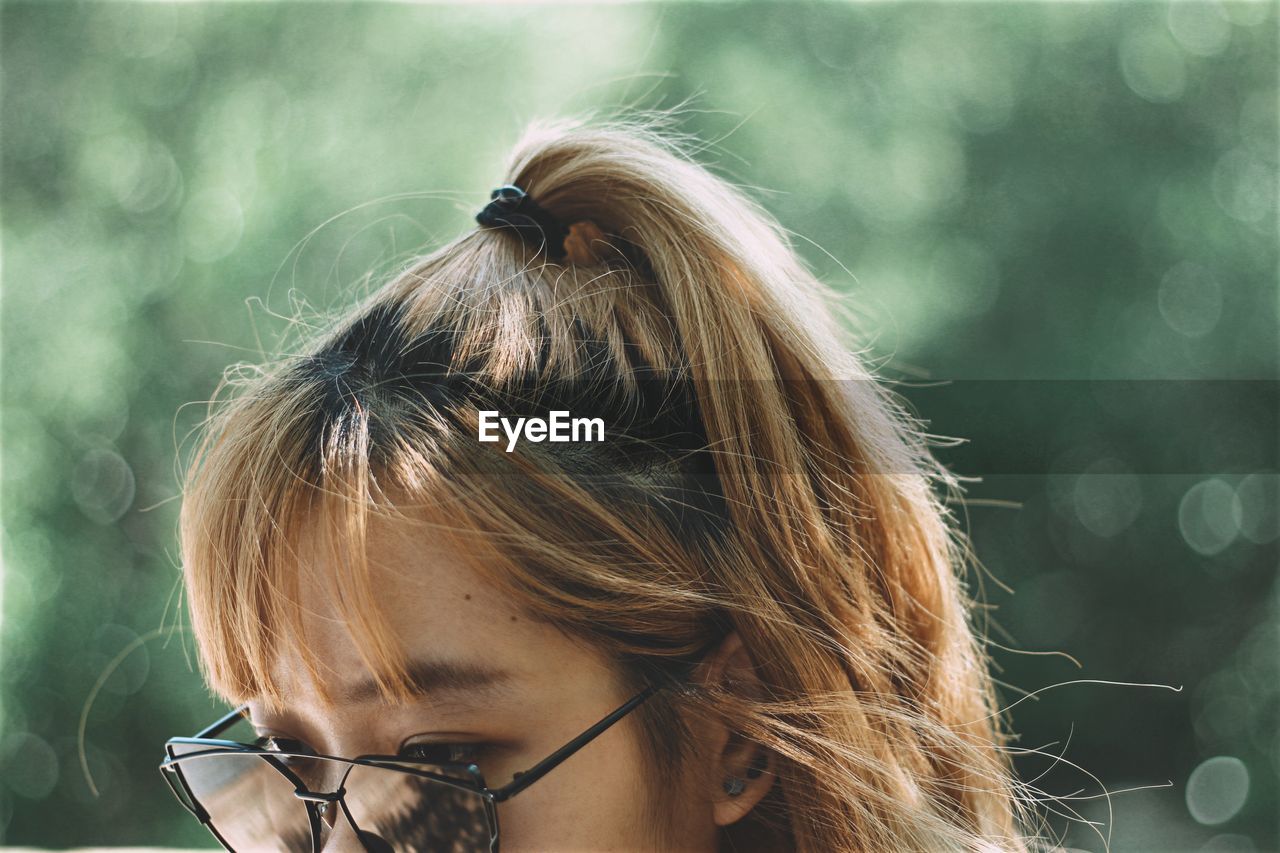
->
[180, 114, 1029, 853]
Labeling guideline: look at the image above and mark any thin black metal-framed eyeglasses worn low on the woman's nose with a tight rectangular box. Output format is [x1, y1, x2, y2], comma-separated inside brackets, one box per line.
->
[160, 684, 662, 853]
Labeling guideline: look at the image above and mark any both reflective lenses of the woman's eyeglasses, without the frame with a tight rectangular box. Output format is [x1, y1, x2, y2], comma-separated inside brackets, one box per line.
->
[173, 744, 490, 853]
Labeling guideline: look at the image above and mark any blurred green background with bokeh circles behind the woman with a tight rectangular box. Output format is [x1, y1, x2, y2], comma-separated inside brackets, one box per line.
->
[0, 3, 1280, 850]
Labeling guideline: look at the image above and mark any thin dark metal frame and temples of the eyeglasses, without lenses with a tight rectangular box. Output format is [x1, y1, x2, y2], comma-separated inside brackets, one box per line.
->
[159, 684, 667, 853]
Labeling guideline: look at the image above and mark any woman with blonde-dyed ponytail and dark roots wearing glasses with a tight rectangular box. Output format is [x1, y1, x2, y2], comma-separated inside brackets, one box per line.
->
[165, 119, 1028, 853]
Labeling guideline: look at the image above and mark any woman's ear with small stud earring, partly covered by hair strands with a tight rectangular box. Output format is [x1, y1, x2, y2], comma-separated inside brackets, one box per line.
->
[698, 631, 774, 826]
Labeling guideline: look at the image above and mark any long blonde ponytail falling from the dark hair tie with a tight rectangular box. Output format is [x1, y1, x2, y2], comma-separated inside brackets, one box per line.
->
[483, 114, 1021, 850]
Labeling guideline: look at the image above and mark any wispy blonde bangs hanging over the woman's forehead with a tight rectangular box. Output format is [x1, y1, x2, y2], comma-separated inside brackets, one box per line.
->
[182, 368, 472, 711]
